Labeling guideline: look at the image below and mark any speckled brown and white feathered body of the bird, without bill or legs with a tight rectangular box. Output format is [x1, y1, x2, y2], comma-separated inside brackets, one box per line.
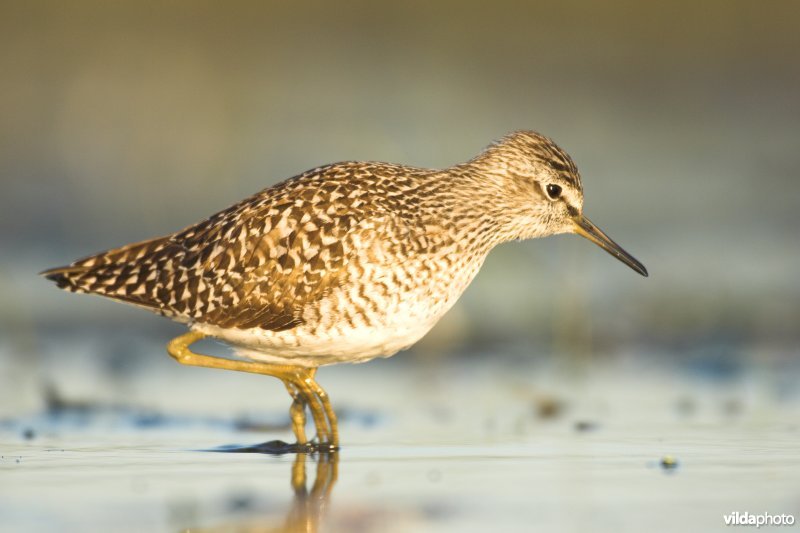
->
[44, 131, 644, 367]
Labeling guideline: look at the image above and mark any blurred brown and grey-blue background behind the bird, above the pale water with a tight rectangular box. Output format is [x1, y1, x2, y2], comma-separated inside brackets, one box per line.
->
[0, 0, 800, 528]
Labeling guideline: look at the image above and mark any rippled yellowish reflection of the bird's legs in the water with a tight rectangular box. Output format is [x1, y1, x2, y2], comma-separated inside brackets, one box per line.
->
[195, 452, 339, 533]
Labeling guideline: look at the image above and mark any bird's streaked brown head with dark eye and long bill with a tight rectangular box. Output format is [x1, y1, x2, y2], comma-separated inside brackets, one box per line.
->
[471, 131, 647, 276]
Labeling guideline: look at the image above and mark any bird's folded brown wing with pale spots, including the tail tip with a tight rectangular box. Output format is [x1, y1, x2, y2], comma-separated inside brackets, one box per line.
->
[44, 162, 396, 331]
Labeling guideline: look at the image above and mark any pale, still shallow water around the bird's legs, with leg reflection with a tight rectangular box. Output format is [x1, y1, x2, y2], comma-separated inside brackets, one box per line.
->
[0, 348, 800, 531]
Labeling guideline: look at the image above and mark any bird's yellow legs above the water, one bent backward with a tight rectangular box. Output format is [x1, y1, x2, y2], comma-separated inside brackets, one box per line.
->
[167, 331, 339, 447]
